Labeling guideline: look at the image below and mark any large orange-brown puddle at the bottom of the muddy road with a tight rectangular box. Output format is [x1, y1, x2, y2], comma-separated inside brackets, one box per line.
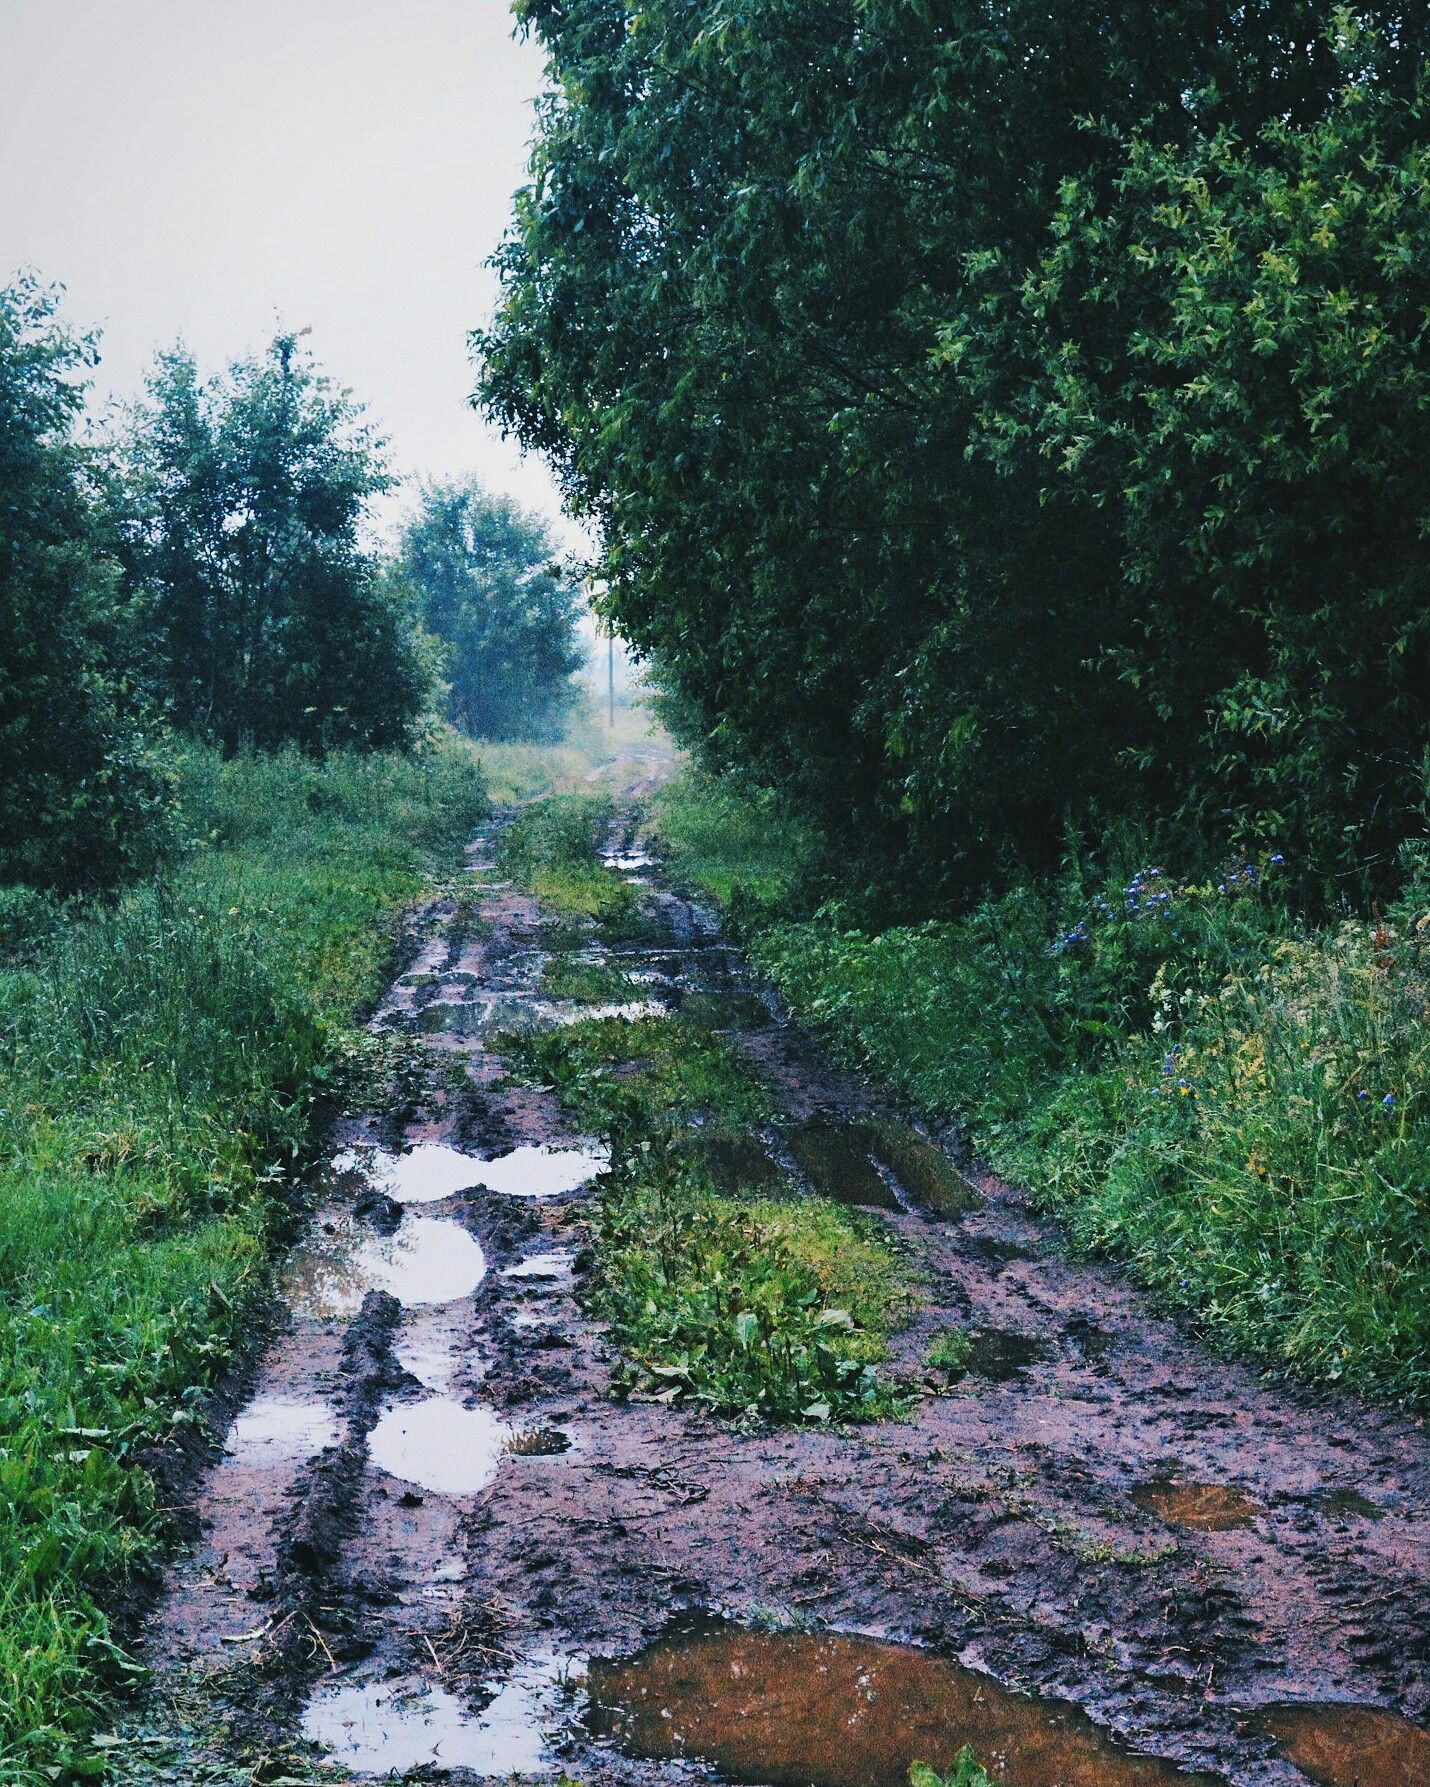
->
[586, 1630, 1208, 1787]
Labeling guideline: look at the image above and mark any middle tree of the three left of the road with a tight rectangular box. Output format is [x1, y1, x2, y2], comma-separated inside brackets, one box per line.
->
[127, 336, 434, 751]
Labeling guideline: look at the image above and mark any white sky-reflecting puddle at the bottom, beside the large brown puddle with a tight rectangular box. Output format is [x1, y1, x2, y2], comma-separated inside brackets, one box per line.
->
[302, 1658, 572, 1780]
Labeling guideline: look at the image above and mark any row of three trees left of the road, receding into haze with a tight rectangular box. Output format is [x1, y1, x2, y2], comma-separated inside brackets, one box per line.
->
[0, 289, 581, 890]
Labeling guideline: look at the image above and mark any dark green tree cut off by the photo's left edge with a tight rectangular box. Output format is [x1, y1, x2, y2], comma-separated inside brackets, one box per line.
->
[0, 277, 168, 892]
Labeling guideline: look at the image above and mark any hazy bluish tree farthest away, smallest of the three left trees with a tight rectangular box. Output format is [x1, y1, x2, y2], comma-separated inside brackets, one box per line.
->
[399, 481, 583, 738]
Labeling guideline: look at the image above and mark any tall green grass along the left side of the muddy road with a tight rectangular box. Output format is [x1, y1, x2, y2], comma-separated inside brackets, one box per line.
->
[0, 743, 486, 1783]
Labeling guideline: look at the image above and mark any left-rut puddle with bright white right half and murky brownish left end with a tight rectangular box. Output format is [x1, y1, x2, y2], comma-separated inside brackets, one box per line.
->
[282, 1215, 486, 1319]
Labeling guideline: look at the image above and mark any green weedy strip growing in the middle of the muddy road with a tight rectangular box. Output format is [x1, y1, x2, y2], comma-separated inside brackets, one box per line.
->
[502, 1017, 910, 1421]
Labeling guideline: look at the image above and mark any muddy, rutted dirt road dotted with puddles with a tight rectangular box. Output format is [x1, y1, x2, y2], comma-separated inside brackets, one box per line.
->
[128, 789, 1430, 1787]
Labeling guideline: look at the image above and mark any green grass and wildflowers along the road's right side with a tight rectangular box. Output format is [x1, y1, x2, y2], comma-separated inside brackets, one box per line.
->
[656, 781, 1430, 1401]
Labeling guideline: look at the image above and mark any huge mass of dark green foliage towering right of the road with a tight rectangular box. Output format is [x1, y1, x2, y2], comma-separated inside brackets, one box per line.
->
[477, 0, 1430, 904]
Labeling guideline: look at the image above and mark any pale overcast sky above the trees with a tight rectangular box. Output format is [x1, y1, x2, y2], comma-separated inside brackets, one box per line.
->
[0, 0, 577, 540]
